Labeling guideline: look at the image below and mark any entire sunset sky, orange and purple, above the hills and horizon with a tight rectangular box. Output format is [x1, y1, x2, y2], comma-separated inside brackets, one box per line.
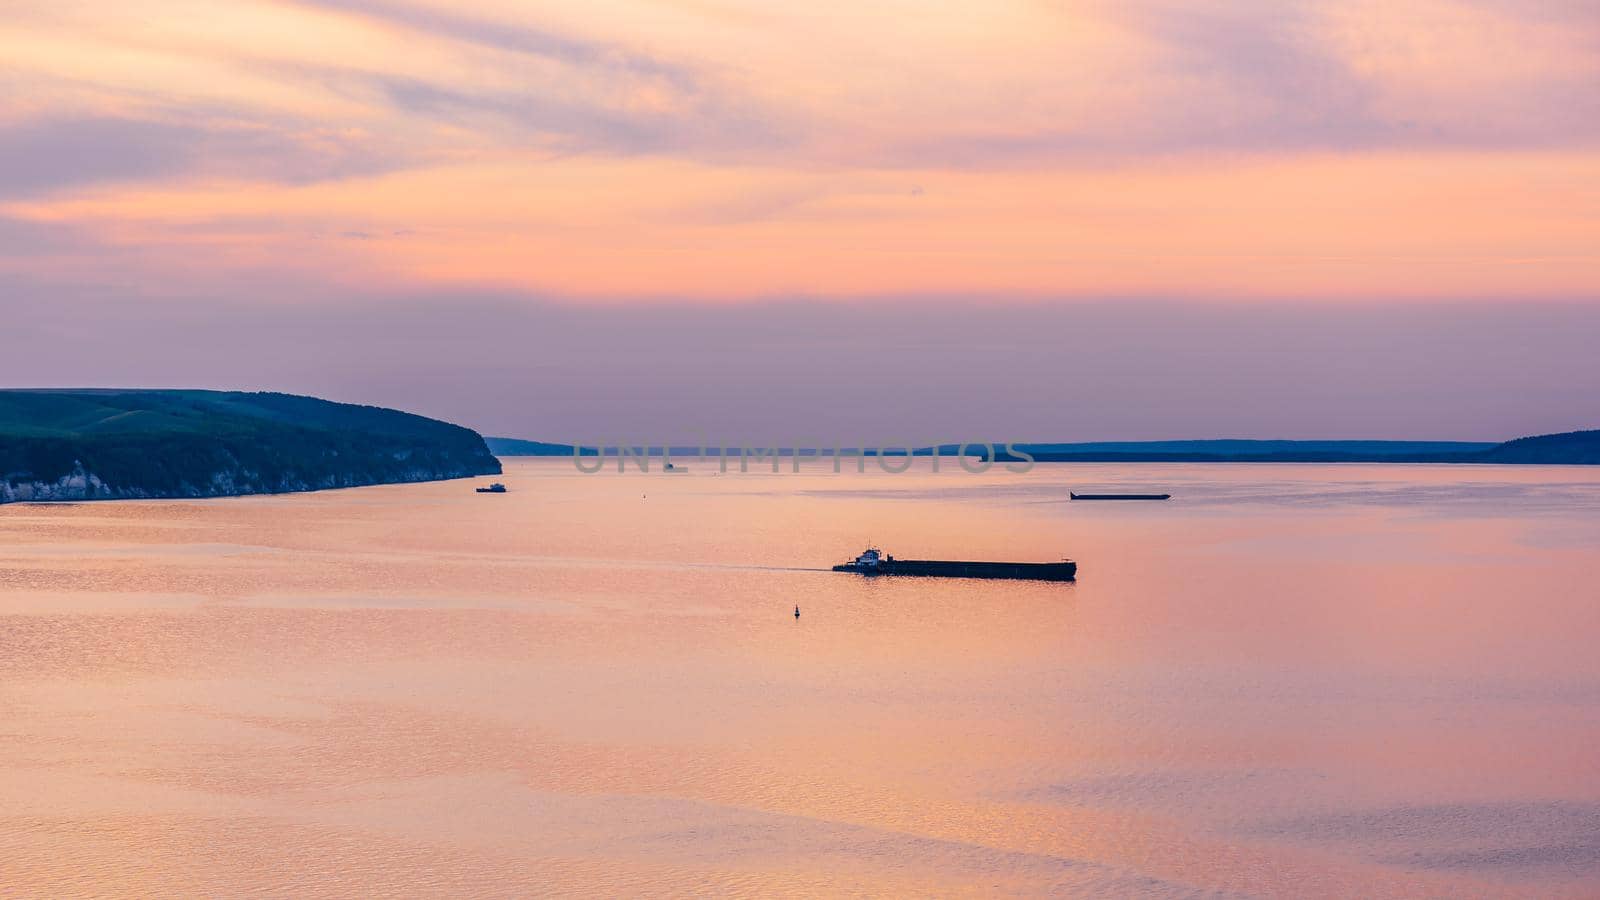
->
[0, 0, 1600, 442]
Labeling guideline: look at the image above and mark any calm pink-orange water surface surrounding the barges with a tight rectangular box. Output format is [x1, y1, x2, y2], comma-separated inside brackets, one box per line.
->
[0, 460, 1600, 897]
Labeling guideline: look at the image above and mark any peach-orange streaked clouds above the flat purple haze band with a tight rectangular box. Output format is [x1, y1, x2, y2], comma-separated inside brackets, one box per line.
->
[0, 0, 1600, 301]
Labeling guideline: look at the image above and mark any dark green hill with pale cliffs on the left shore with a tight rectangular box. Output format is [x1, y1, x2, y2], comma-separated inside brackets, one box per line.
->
[0, 389, 501, 503]
